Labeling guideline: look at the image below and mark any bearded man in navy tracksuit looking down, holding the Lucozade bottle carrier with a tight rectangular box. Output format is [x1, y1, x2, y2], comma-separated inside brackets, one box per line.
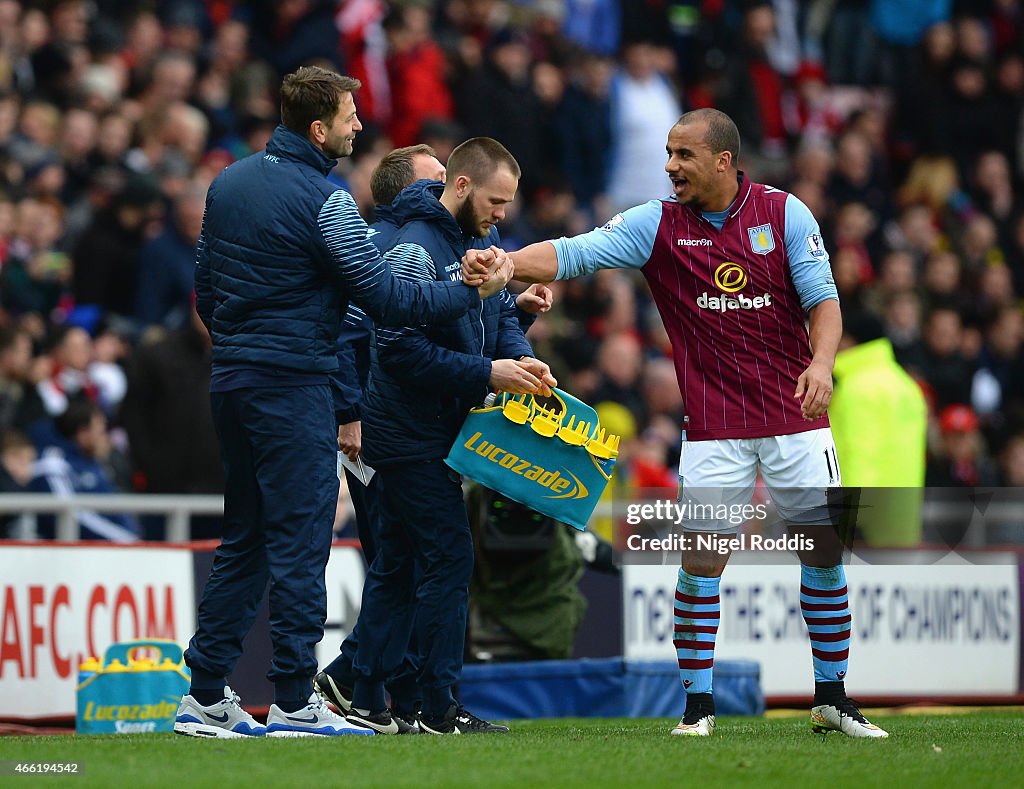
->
[348, 137, 555, 734]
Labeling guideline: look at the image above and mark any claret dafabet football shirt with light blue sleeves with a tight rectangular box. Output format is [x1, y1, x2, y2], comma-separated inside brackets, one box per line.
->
[554, 177, 839, 441]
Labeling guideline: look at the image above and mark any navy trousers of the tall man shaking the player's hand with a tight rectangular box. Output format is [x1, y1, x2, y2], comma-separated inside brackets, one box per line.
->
[185, 385, 338, 701]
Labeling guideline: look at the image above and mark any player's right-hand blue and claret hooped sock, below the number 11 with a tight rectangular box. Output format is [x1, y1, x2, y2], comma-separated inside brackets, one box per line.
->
[800, 565, 852, 683]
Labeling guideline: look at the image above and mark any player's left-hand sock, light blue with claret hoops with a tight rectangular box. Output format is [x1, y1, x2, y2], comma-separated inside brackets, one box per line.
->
[673, 568, 722, 695]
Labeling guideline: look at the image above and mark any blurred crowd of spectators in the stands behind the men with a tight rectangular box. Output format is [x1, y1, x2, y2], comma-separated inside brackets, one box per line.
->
[0, 0, 1024, 539]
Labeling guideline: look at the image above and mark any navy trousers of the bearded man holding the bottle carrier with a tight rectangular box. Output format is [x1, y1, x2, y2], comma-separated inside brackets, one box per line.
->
[352, 459, 473, 716]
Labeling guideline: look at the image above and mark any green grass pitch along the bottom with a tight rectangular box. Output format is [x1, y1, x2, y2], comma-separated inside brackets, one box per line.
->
[0, 710, 1024, 789]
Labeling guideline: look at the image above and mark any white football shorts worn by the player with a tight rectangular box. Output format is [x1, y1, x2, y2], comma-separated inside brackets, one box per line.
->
[679, 428, 842, 533]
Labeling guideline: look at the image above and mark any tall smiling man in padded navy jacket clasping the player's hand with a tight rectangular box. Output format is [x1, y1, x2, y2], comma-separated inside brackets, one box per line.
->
[175, 67, 510, 737]
